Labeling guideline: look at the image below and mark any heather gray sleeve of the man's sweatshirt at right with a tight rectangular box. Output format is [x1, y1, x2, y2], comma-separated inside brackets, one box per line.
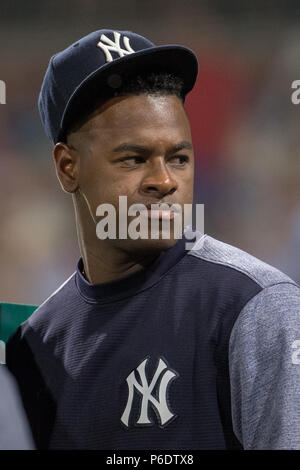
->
[229, 283, 300, 450]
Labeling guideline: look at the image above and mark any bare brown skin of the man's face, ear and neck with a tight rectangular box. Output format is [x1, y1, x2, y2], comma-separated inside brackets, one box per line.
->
[54, 94, 194, 284]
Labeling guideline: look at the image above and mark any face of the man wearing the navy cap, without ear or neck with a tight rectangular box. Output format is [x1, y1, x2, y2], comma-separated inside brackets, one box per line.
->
[69, 94, 194, 255]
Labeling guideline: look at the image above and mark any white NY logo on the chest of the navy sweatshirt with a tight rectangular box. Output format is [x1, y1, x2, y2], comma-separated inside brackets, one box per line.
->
[121, 358, 177, 427]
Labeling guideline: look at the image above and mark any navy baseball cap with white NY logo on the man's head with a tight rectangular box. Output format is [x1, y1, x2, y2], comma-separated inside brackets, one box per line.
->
[38, 29, 198, 144]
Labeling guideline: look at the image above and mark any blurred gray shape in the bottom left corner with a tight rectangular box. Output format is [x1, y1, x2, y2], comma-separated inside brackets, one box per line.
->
[0, 365, 34, 450]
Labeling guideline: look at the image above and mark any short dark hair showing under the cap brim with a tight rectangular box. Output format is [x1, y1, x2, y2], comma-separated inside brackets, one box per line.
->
[64, 73, 185, 141]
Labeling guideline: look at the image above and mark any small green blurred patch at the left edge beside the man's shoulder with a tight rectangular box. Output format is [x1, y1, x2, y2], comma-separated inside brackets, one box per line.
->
[0, 303, 37, 343]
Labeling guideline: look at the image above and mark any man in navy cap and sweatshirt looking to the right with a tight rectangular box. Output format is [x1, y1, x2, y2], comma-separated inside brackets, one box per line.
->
[7, 30, 300, 450]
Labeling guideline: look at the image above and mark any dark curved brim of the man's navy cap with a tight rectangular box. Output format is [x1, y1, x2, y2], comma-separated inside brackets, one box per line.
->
[58, 45, 198, 140]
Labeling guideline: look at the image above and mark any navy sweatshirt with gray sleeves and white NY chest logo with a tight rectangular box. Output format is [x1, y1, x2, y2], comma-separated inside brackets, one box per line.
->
[7, 235, 300, 450]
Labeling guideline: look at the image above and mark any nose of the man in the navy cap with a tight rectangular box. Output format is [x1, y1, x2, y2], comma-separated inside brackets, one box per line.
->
[141, 162, 177, 197]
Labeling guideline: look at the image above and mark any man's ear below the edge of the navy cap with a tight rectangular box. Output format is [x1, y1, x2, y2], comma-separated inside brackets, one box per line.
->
[53, 142, 80, 193]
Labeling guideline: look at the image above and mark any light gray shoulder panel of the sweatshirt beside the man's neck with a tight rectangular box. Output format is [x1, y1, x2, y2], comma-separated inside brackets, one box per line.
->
[188, 235, 296, 289]
